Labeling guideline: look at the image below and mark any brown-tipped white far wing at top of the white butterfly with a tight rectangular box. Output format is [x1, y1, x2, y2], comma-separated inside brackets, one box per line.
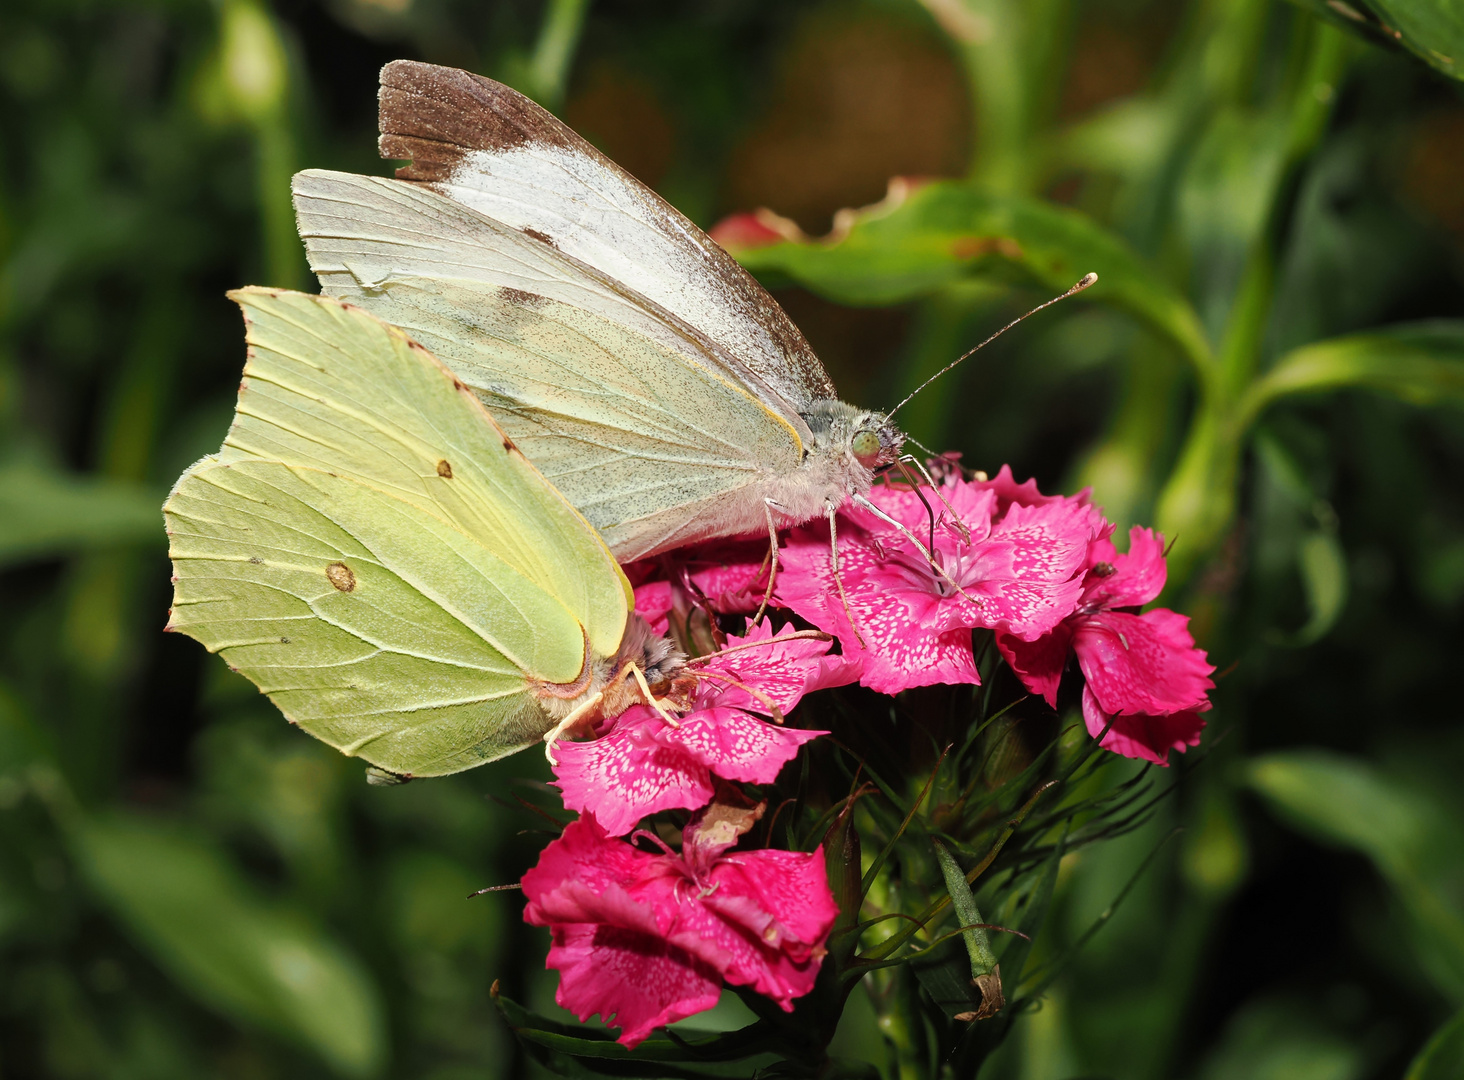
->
[371, 60, 836, 413]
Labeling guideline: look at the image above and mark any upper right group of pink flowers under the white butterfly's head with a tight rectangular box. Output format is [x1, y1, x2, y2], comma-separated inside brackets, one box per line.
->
[777, 465, 1215, 765]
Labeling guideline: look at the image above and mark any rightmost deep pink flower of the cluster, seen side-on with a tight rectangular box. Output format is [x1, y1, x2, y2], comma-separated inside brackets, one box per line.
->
[997, 527, 1215, 765]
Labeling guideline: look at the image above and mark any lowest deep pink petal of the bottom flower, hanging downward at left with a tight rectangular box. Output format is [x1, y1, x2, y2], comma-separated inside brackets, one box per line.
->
[546, 923, 722, 1046]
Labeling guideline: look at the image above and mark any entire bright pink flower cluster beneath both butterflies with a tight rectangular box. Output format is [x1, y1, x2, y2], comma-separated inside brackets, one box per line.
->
[523, 468, 1214, 1046]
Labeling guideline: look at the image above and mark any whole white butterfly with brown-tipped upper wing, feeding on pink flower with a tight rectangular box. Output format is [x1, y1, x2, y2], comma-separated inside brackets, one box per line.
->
[294, 60, 905, 560]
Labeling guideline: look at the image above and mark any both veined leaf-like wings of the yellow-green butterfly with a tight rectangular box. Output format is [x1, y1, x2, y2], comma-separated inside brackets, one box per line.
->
[164, 290, 630, 776]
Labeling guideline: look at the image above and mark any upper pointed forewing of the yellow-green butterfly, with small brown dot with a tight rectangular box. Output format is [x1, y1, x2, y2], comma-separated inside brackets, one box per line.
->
[221, 288, 630, 656]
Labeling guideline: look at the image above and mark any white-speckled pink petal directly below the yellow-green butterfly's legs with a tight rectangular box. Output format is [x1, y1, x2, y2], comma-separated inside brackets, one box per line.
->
[553, 705, 717, 836]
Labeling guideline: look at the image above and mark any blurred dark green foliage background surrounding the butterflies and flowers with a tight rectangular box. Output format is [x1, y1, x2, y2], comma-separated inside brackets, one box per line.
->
[0, 0, 1464, 1080]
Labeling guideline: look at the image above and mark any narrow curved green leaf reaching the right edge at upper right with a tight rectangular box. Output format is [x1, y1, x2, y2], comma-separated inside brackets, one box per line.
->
[1241, 319, 1464, 423]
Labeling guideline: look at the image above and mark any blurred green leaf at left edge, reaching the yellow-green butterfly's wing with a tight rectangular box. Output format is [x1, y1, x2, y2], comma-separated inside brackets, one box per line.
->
[0, 462, 164, 566]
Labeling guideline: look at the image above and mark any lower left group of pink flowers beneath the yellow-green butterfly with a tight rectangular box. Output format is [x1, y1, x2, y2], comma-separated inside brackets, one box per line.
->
[523, 617, 858, 1046]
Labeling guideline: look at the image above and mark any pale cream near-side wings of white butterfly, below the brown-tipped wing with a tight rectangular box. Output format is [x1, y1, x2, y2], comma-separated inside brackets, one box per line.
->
[296, 173, 808, 559]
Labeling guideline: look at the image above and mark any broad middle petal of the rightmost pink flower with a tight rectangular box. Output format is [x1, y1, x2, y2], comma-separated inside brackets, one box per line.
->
[1073, 607, 1215, 716]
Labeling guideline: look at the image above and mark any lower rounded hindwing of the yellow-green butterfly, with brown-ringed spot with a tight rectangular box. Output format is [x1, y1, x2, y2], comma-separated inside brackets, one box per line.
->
[167, 461, 559, 776]
